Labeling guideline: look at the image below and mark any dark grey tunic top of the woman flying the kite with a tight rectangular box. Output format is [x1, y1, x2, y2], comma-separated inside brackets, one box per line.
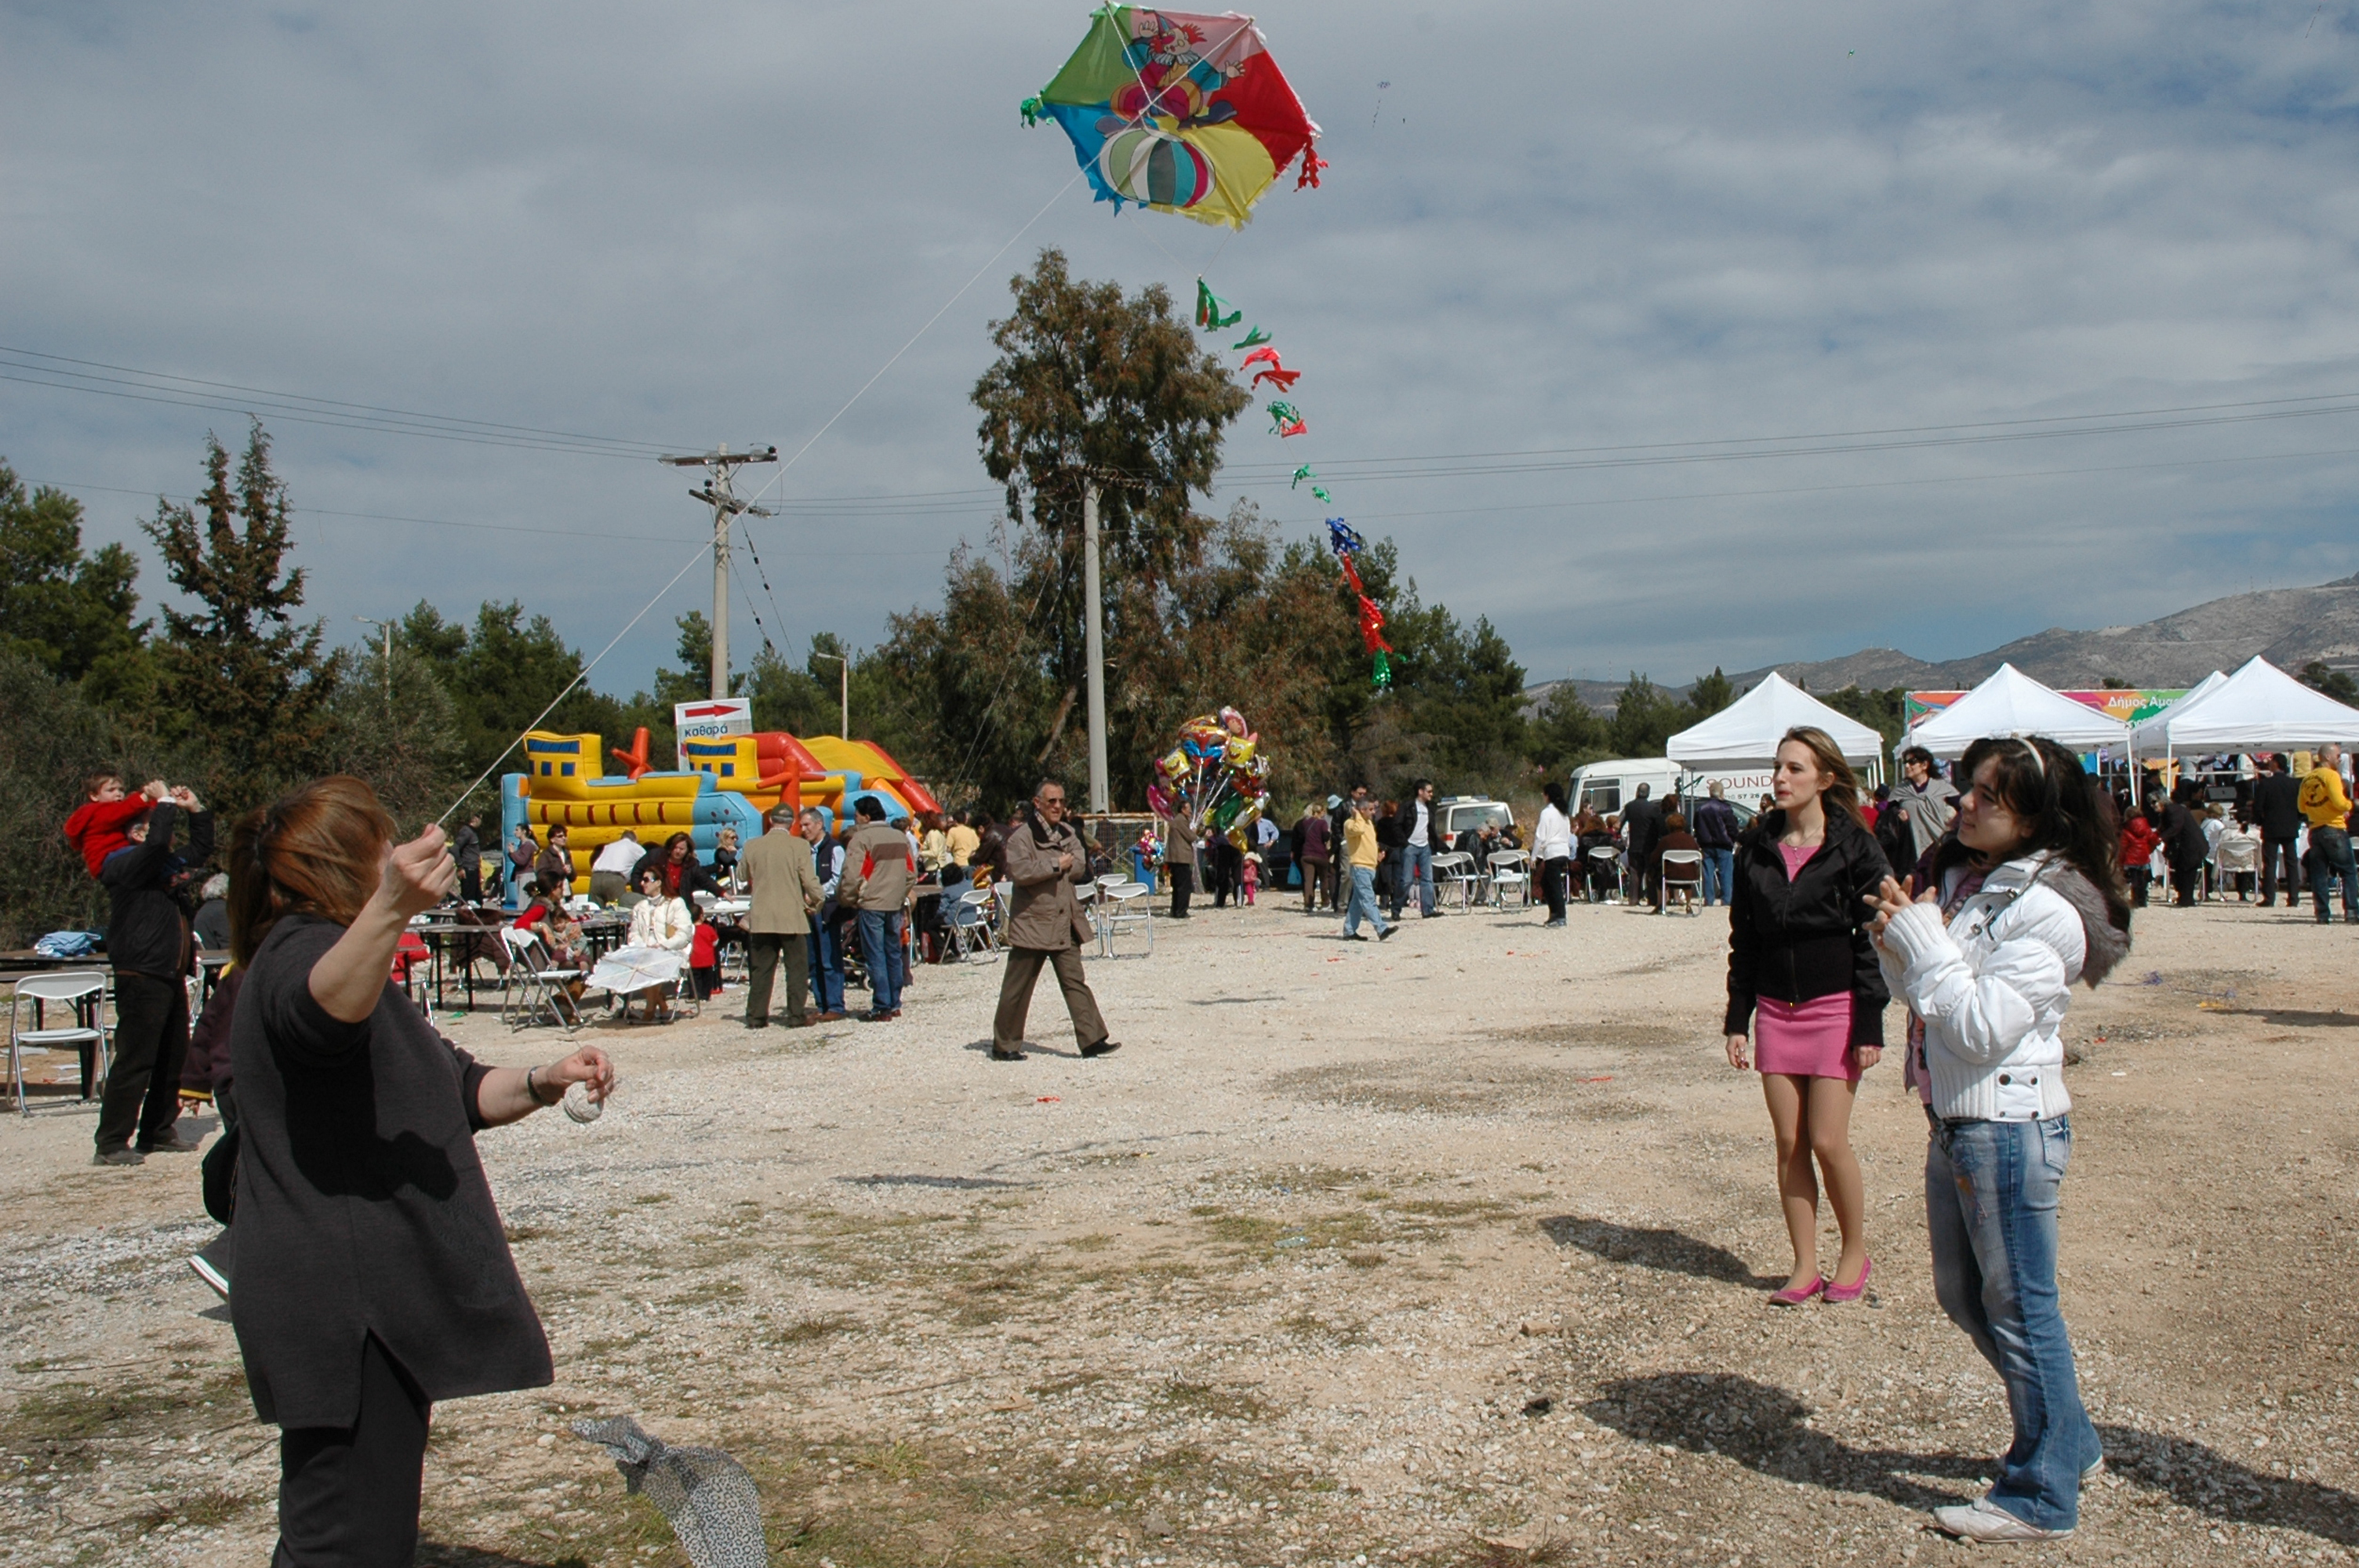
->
[229, 915, 550, 1427]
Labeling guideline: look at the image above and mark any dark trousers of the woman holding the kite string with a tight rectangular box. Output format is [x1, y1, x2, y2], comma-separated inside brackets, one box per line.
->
[271, 1334, 434, 1568]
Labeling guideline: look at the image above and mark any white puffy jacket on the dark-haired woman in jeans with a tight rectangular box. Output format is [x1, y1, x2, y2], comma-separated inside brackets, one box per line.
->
[1877, 856, 2088, 1123]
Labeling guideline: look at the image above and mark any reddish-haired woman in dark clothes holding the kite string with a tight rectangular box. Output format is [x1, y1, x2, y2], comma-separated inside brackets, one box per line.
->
[229, 778, 613, 1568]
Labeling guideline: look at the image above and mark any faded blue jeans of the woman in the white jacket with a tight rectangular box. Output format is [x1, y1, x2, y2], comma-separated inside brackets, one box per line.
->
[1925, 1116, 2104, 1530]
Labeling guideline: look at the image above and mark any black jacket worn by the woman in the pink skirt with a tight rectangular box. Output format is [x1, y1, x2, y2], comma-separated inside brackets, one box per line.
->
[1725, 811, 1892, 1044]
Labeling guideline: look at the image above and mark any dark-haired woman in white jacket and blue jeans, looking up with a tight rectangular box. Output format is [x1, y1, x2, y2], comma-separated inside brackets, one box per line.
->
[1870, 738, 2130, 1542]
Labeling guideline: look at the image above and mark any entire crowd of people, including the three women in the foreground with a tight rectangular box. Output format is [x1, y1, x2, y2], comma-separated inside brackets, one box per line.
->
[32, 728, 2359, 1563]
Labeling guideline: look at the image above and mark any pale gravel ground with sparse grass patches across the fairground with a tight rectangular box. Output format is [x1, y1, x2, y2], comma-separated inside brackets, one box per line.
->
[0, 886, 2359, 1568]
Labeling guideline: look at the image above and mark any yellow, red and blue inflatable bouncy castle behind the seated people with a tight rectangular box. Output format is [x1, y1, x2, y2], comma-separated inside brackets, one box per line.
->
[500, 728, 941, 894]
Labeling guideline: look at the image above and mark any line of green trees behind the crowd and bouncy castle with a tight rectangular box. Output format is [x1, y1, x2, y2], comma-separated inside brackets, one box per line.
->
[0, 250, 1899, 946]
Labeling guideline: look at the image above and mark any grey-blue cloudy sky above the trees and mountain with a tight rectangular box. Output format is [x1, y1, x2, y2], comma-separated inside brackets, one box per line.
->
[0, 0, 2359, 691]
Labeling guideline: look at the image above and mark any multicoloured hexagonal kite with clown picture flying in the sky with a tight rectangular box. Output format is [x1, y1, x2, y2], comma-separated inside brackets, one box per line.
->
[1021, 5, 1325, 229]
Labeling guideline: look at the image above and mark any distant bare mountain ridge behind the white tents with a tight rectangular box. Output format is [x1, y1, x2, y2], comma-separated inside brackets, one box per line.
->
[1524, 575, 2359, 712]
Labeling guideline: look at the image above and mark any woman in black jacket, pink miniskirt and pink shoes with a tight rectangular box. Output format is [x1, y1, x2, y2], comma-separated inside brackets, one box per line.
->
[1722, 726, 1892, 1306]
